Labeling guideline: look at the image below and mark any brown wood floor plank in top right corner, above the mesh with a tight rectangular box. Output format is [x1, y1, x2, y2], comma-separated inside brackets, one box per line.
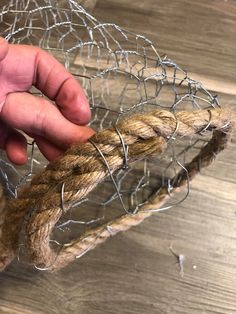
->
[92, 0, 236, 94]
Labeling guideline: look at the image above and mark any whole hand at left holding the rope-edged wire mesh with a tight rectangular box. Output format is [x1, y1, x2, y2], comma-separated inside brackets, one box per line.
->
[0, 37, 94, 164]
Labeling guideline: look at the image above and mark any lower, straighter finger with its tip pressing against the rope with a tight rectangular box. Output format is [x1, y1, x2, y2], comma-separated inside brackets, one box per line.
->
[1, 92, 94, 148]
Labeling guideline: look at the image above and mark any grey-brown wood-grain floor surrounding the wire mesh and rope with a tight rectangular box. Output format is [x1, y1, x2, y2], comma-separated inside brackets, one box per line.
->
[0, 0, 236, 314]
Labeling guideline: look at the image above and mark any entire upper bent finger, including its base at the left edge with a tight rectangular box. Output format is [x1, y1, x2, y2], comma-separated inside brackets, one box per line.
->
[0, 44, 90, 124]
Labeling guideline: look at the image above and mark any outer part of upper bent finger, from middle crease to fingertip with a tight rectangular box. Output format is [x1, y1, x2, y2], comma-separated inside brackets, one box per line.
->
[35, 50, 90, 124]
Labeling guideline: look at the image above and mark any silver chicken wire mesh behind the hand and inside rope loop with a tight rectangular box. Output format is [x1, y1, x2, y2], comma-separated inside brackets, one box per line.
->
[0, 0, 220, 264]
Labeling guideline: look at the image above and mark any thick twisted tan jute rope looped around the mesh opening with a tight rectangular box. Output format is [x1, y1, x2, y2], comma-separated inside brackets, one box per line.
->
[0, 108, 234, 271]
